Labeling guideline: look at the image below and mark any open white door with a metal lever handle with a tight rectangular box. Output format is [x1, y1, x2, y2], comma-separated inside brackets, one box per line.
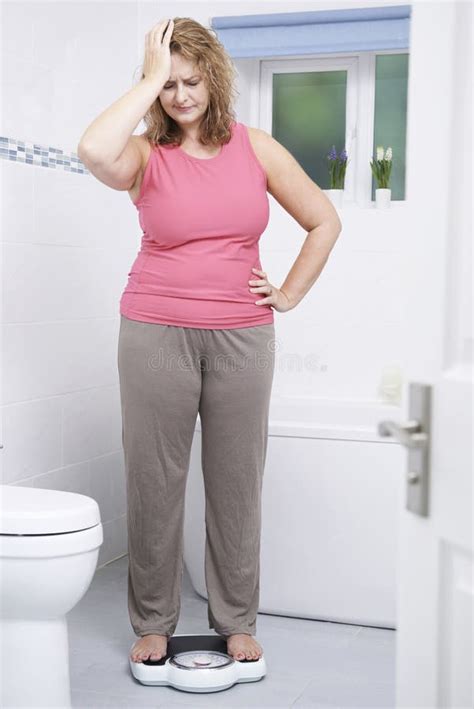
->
[381, 2, 474, 709]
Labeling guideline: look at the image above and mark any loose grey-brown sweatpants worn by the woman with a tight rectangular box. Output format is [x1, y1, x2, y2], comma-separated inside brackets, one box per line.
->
[118, 316, 275, 636]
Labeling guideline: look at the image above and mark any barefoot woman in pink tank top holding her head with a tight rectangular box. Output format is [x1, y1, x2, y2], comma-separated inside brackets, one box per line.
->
[78, 18, 341, 662]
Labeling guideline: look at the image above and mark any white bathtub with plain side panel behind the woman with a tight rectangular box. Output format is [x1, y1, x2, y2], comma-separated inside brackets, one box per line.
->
[184, 398, 406, 628]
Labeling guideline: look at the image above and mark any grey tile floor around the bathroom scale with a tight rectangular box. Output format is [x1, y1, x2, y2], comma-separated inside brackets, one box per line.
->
[68, 556, 396, 709]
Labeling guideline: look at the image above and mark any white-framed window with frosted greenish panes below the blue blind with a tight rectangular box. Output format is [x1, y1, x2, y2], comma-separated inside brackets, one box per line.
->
[259, 50, 409, 205]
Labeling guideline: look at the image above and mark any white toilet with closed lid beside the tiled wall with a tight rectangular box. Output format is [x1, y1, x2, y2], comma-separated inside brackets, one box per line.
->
[0, 485, 103, 709]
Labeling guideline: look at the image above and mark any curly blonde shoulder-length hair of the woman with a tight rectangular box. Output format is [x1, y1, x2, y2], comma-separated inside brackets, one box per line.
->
[141, 17, 238, 146]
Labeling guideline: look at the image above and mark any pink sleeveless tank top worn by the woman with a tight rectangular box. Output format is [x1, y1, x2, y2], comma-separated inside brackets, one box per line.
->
[120, 122, 273, 329]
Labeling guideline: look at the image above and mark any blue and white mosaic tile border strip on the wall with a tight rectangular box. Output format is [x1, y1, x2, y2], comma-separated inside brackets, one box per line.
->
[0, 135, 90, 175]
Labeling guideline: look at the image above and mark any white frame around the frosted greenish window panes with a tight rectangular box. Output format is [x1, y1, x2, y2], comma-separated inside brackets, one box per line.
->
[256, 49, 407, 208]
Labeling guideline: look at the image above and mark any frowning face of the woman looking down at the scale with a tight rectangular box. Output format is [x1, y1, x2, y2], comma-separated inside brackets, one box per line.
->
[158, 53, 209, 128]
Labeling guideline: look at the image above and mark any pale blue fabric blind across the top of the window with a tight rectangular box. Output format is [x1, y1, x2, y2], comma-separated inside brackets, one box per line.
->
[211, 5, 411, 58]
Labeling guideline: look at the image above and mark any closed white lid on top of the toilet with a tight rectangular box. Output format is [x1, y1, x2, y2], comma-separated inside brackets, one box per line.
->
[0, 485, 100, 534]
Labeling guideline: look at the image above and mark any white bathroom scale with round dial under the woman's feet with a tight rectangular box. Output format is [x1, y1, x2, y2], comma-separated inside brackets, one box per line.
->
[129, 633, 266, 692]
